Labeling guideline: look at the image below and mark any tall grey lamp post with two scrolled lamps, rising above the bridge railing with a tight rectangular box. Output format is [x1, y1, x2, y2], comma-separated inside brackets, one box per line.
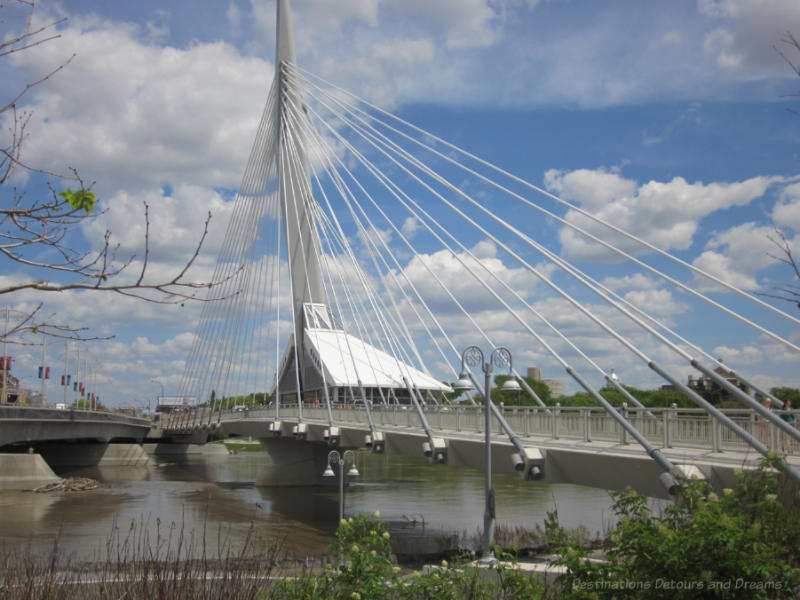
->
[453, 346, 520, 563]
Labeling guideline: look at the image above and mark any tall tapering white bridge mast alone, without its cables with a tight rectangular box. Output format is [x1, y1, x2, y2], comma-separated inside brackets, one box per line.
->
[275, 0, 327, 398]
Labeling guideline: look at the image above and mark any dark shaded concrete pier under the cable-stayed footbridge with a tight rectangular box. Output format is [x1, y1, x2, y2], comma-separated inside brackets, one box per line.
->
[256, 437, 341, 487]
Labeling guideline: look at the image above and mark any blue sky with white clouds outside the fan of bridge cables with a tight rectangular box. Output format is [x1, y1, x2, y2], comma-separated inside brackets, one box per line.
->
[0, 0, 800, 405]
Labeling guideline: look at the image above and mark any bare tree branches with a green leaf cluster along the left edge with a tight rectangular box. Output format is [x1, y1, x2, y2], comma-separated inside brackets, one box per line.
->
[0, 0, 241, 341]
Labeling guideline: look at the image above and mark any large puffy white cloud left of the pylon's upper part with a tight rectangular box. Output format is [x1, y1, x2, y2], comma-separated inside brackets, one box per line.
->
[12, 12, 272, 192]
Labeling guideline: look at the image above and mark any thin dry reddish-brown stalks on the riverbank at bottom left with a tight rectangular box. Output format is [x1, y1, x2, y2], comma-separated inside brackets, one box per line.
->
[0, 521, 282, 600]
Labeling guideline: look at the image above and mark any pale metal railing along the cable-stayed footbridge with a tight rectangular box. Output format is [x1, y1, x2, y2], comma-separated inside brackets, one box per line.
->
[216, 404, 800, 452]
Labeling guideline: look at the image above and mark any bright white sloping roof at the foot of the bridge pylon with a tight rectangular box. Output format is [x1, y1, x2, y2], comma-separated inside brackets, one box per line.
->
[305, 329, 453, 392]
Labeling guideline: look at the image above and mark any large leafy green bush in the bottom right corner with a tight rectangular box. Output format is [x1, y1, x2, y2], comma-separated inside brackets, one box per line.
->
[556, 458, 800, 600]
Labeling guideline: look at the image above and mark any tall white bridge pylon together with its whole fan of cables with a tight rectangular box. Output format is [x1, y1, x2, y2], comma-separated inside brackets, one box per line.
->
[181, 0, 800, 492]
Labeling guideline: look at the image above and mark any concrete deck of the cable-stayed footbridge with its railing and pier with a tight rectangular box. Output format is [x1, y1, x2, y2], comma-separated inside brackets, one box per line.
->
[208, 406, 800, 498]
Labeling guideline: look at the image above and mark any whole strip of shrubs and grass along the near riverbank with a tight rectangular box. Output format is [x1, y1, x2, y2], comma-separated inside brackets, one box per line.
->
[0, 458, 800, 600]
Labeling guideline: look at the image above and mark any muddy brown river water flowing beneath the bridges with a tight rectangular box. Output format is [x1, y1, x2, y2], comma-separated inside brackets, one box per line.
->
[0, 452, 611, 560]
